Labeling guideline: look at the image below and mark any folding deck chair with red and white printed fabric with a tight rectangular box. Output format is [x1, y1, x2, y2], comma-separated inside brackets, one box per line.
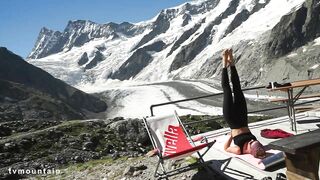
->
[143, 111, 215, 178]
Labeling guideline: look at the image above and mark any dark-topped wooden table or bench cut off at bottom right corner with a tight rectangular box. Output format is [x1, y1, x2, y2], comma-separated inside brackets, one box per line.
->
[269, 129, 320, 180]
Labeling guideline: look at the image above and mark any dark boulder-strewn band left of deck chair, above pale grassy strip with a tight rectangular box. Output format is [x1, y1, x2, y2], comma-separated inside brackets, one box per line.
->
[0, 118, 150, 179]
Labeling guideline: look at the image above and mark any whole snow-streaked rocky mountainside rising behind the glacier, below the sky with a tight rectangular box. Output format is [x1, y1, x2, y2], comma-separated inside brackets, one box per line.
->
[28, 0, 320, 90]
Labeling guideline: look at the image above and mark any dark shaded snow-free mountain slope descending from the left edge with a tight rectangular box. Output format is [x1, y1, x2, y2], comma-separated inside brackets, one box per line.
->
[0, 47, 107, 122]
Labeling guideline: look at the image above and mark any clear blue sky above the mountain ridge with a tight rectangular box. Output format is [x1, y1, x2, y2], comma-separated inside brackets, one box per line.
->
[0, 0, 189, 57]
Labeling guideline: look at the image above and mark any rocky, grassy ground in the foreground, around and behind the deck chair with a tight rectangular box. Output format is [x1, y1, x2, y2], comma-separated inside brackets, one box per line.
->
[0, 112, 230, 179]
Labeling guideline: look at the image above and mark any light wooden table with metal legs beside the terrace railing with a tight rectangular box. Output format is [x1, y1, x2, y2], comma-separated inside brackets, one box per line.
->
[270, 78, 320, 132]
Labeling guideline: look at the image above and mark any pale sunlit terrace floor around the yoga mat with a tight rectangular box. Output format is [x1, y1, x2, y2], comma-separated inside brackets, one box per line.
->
[195, 109, 320, 180]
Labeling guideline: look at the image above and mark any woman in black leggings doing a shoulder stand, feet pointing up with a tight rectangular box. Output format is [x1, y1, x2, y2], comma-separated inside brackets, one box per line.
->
[221, 49, 266, 158]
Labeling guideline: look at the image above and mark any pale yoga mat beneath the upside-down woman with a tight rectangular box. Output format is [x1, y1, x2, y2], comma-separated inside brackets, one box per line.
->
[213, 135, 284, 170]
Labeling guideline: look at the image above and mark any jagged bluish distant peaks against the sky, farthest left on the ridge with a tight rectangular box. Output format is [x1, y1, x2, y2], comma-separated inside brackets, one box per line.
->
[28, 20, 144, 59]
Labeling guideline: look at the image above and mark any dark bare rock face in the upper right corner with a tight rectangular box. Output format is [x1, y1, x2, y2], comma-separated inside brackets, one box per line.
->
[266, 0, 320, 58]
